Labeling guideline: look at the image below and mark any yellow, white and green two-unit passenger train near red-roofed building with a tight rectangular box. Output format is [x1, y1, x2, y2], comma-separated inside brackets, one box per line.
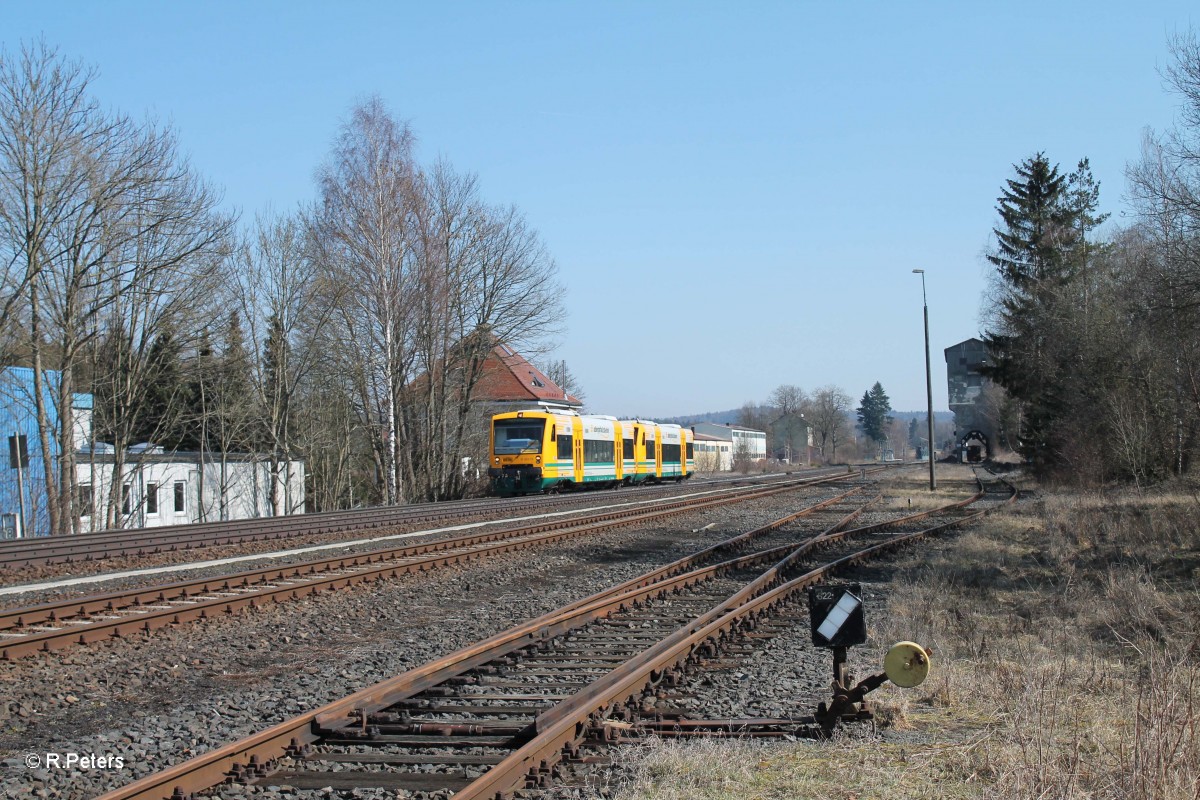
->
[487, 409, 696, 497]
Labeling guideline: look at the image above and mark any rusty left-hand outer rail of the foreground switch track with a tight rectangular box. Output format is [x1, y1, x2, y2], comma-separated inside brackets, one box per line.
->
[91, 474, 962, 800]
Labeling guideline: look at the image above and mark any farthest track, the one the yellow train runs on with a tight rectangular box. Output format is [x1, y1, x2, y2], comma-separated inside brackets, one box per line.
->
[0, 470, 846, 572]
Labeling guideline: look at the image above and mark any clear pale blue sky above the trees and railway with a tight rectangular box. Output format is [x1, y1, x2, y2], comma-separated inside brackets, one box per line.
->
[0, 0, 1200, 416]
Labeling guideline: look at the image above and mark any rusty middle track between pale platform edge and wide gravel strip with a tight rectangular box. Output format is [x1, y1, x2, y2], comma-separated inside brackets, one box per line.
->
[0, 474, 873, 661]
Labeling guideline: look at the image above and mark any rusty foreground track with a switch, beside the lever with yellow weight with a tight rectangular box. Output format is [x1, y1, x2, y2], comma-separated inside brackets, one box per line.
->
[102, 470, 1015, 800]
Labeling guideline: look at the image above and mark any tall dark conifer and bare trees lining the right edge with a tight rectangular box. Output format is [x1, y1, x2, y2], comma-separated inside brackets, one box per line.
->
[984, 35, 1200, 485]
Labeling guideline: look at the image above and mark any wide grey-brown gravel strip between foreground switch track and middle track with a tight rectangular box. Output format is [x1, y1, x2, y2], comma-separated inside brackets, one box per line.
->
[0, 489, 864, 798]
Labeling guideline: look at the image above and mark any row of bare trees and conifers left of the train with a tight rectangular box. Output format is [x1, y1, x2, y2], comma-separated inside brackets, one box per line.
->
[0, 42, 562, 533]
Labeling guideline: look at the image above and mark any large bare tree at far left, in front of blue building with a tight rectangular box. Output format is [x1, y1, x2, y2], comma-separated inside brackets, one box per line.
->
[0, 44, 227, 533]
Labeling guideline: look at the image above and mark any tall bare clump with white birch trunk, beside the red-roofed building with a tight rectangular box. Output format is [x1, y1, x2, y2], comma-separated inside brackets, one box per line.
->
[314, 100, 562, 503]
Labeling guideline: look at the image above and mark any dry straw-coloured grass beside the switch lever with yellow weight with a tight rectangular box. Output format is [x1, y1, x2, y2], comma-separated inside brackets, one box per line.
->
[620, 479, 1200, 800]
